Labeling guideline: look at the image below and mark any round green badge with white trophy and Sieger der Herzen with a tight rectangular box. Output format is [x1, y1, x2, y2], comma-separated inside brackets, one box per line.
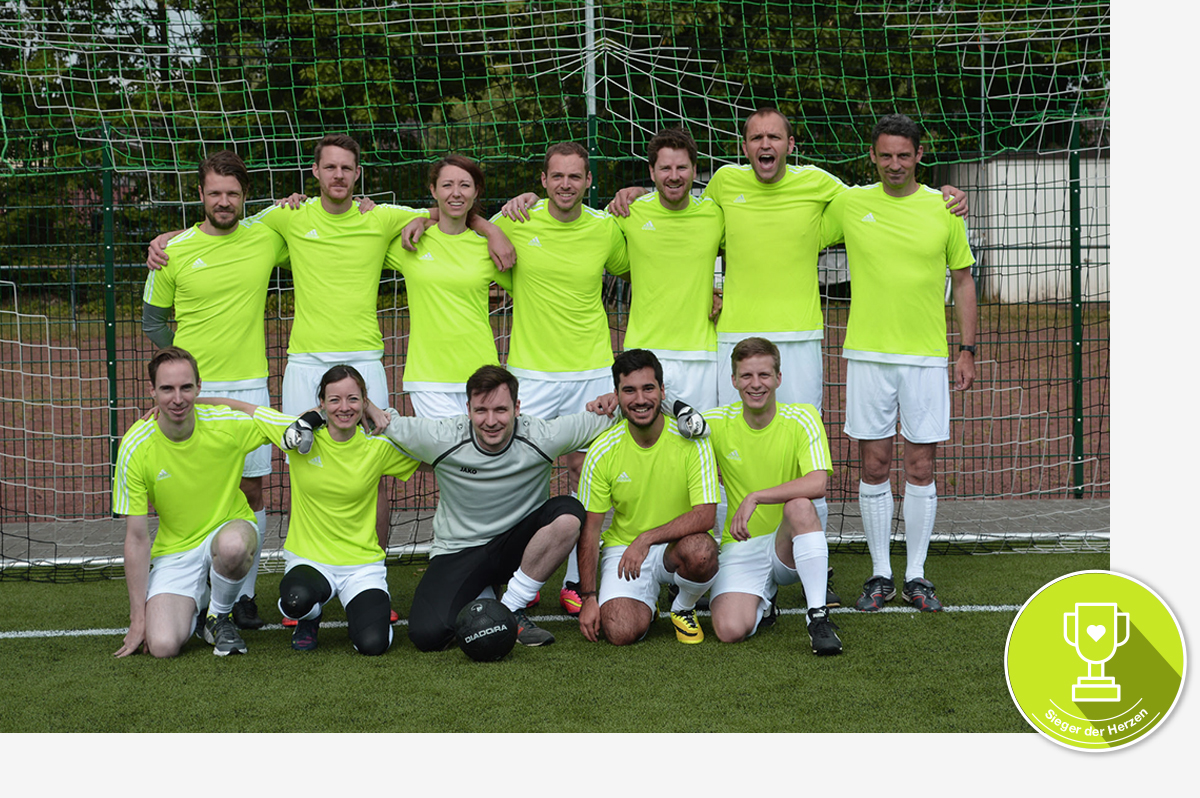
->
[1004, 571, 1187, 751]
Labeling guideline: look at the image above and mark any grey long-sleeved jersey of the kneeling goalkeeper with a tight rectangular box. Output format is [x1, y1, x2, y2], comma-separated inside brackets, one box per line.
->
[384, 408, 620, 557]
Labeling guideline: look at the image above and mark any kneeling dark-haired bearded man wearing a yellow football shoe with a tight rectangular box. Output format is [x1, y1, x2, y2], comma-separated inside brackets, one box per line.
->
[578, 349, 719, 646]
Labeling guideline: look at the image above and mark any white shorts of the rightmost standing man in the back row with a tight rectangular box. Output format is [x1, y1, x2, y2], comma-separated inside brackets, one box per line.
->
[845, 360, 950, 443]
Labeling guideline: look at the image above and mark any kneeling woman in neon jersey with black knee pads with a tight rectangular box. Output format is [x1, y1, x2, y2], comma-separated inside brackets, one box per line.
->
[201, 365, 420, 655]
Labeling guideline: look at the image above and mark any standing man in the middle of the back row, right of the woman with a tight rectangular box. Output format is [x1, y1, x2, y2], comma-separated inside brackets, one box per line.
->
[492, 142, 629, 616]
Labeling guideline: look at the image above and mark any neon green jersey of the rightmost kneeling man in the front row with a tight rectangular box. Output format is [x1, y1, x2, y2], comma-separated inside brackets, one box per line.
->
[703, 402, 833, 544]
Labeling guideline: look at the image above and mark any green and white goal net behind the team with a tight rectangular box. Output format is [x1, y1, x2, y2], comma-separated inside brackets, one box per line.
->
[0, 0, 1110, 577]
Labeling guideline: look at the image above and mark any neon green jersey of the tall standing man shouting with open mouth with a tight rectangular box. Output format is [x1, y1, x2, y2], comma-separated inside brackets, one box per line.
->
[704, 166, 846, 342]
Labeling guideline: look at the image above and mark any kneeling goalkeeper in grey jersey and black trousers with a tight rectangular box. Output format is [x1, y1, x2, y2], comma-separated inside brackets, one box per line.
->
[372, 366, 613, 652]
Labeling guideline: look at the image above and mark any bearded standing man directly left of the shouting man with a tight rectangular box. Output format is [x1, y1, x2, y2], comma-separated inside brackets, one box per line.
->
[617, 130, 725, 412]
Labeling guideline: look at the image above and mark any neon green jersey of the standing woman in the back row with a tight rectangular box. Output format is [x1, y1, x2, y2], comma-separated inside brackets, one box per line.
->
[381, 225, 500, 390]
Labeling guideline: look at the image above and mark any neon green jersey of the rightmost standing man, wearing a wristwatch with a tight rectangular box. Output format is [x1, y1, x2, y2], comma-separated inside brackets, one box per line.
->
[824, 184, 974, 366]
